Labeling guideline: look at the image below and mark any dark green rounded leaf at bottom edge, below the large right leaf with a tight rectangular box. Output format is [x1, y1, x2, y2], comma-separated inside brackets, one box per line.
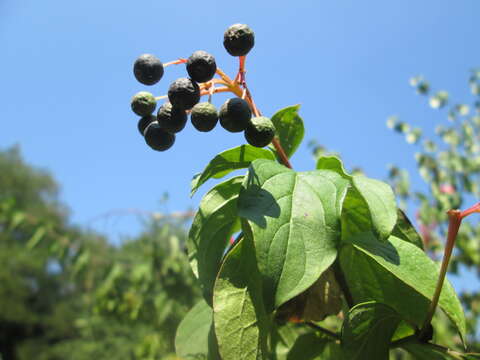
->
[342, 302, 401, 360]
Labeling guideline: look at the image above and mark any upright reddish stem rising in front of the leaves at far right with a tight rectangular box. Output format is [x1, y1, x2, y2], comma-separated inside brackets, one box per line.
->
[418, 210, 462, 339]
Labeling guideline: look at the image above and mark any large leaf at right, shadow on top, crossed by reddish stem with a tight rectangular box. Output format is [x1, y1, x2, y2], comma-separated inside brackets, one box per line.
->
[340, 234, 466, 339]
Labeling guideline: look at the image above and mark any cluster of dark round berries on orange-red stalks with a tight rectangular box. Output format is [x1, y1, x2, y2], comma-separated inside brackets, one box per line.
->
[131, 24, 275, 151]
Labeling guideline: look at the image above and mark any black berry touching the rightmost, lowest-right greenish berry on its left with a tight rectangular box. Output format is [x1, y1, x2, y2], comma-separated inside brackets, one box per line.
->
[219, 97, 252, 132]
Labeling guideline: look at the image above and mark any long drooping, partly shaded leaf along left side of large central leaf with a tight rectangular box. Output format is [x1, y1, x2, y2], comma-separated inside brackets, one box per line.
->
[187, 176, 243, 304]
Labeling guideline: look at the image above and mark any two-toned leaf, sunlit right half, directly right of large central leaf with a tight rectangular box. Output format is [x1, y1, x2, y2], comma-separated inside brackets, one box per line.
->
[342, 175, 397, 239]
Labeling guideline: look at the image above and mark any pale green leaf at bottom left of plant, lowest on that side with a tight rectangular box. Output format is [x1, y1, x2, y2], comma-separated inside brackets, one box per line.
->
[175, 300, 220, 360]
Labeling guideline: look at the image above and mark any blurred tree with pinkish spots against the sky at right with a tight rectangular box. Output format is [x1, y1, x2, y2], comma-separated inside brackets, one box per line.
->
[387, 70, 480, 351]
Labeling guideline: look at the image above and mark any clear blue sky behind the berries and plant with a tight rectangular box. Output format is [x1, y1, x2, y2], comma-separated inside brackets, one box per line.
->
[0, 0, 480, 268]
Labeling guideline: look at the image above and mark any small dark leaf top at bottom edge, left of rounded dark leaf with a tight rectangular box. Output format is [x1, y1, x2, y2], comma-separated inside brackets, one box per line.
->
[287, 333, 347, 360]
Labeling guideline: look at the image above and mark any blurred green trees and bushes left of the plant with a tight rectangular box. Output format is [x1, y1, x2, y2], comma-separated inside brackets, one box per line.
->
[0, 148, 200, 360]
